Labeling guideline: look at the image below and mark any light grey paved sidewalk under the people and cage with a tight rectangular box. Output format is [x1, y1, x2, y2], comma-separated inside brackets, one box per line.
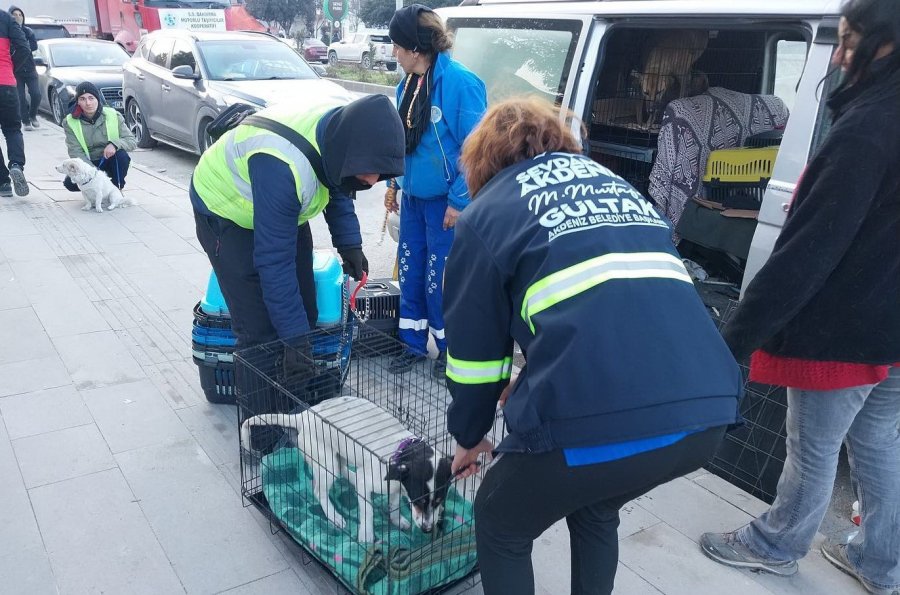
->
[0, 125, 862, 595]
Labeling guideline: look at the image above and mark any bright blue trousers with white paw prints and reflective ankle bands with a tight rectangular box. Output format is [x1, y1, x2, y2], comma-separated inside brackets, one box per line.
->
[397, 192, 454, 353]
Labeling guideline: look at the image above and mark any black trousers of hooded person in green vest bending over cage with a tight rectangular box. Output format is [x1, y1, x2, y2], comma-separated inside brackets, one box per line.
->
[194, 211, 319, 348]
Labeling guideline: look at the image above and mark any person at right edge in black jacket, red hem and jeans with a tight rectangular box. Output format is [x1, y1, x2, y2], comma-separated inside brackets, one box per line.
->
[700, 0, 900, 595]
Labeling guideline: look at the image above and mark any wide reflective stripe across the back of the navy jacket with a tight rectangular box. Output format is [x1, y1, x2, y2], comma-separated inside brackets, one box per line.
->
[520, 252, 693, 336]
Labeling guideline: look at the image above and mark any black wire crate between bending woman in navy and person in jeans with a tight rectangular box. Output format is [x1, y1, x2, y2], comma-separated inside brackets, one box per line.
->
[706, 302, 787, 504]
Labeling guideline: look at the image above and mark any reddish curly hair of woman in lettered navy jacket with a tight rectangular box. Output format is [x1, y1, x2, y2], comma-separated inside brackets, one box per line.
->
[459, 97, 584, 200]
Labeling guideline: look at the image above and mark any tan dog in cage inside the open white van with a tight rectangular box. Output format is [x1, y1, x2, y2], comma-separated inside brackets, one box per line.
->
[634, 29, 709, 125]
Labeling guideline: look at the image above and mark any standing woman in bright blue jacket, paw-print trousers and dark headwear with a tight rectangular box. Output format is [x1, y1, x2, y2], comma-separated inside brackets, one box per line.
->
[385, 4, 487, 379]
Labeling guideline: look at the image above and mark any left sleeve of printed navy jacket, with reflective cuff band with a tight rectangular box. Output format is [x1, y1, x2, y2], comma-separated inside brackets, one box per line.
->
[443, 217, 513, 448]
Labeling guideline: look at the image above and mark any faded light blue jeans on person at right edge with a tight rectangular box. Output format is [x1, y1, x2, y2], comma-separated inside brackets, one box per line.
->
[739, 367, 900, 588]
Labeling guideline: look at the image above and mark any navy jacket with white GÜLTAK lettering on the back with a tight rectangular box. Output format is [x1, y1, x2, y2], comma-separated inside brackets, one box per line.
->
[444, 153, 741, 452]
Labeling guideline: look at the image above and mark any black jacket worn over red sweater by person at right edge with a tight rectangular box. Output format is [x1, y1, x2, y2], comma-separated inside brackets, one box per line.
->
[723, 56, 900, 365]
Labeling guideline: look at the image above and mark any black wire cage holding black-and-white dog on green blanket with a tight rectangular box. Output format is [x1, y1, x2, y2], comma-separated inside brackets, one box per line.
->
[235, 323, 503, 595]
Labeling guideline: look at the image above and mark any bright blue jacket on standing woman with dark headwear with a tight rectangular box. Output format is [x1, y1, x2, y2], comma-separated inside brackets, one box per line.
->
[397, 53, 487, 211]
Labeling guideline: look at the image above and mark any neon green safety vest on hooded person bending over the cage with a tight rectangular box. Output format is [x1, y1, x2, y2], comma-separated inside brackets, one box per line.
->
[193, 99, 344, 229]
